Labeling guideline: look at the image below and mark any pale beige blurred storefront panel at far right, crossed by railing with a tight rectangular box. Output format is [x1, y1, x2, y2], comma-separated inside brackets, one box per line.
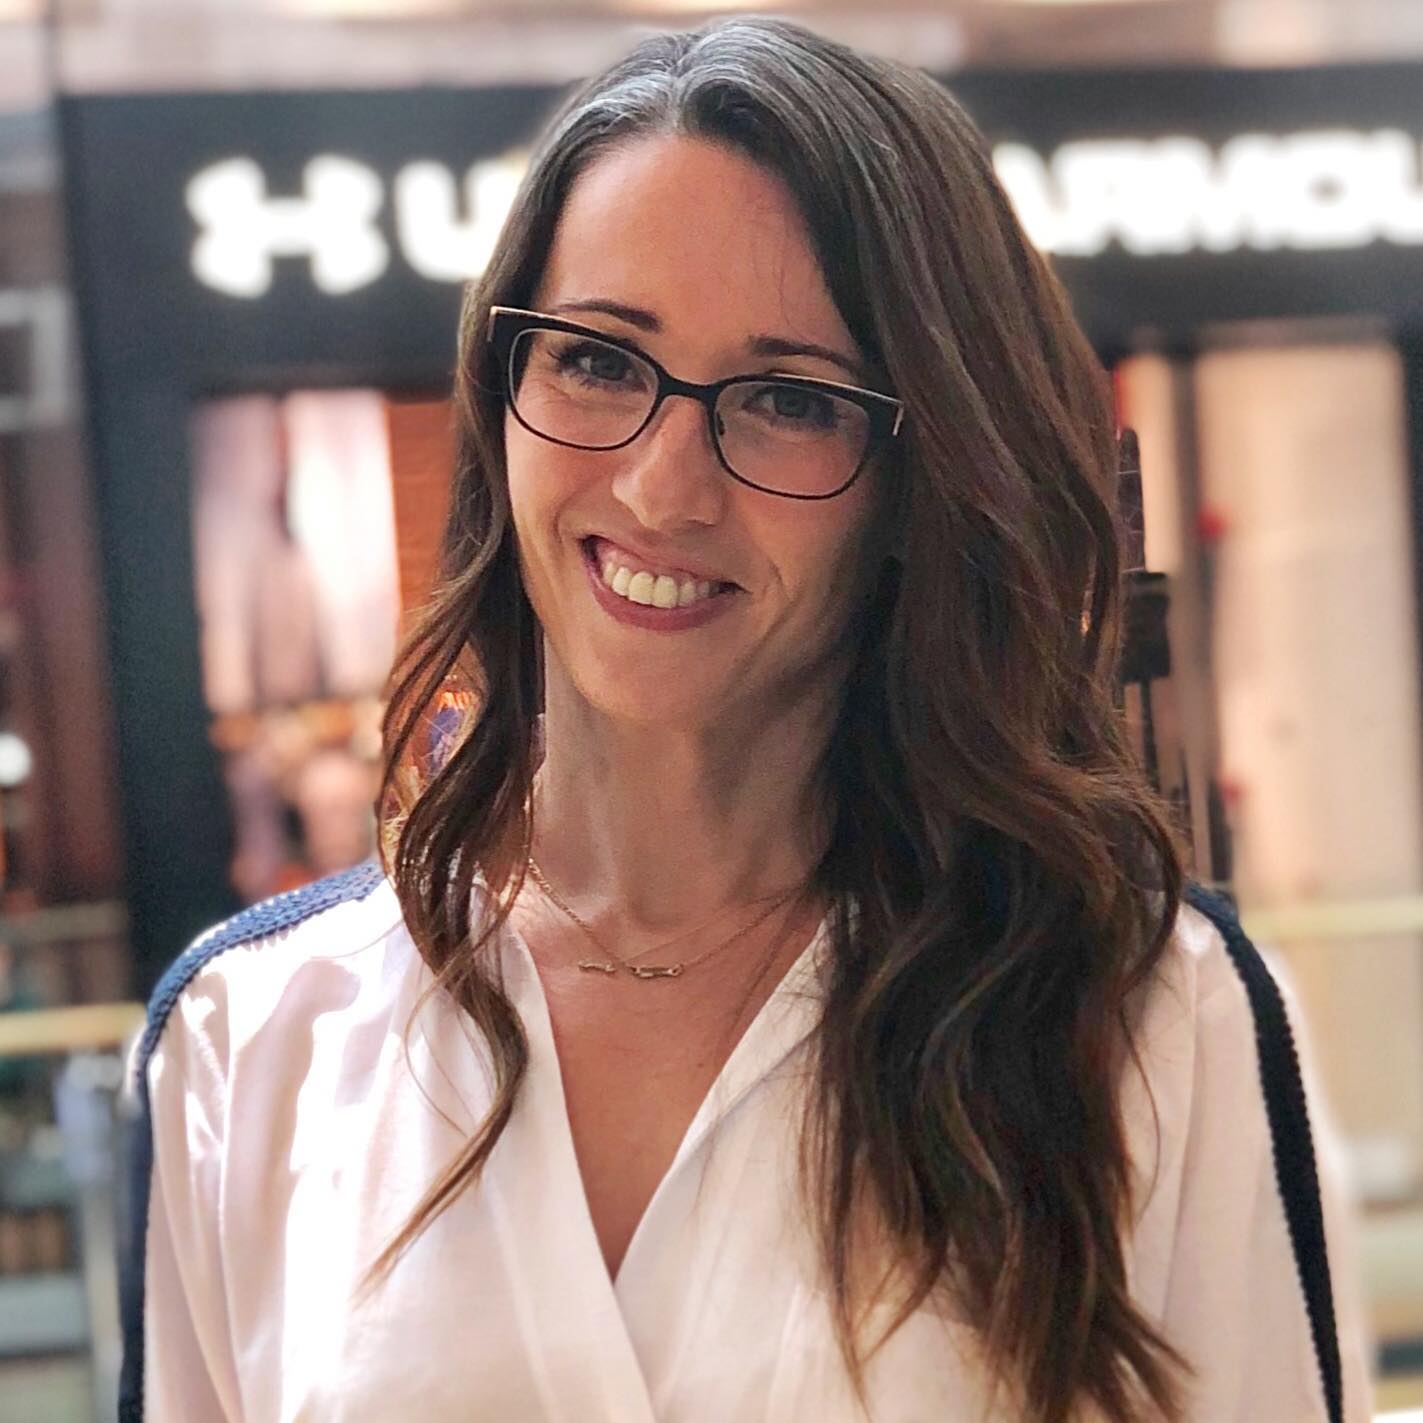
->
[1197, 343, 1423, 1198]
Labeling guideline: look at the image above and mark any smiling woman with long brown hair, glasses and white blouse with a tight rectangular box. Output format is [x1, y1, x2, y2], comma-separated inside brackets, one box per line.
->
[125, 20, 1366, 1423]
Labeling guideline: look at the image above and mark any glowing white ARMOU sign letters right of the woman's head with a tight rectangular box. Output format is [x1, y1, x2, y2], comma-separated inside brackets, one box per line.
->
[993, 129, 1423, 258]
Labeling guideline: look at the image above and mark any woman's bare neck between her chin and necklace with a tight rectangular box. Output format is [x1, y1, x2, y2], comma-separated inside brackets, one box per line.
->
[534, 648, 835, 938]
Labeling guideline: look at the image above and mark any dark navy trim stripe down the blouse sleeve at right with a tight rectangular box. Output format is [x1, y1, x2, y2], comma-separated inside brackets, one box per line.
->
[1185, 884, 1343, 1423]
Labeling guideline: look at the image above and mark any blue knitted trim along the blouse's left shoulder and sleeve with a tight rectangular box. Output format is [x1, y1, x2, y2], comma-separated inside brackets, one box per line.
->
[118, 859, 384, 1423]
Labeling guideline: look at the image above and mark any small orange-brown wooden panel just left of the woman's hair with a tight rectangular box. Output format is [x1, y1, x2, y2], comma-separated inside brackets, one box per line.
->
[386, 400, 454, 622]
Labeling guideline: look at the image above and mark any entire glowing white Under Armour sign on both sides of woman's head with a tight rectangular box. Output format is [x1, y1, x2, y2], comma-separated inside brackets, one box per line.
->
[186, 129, 1423, 299]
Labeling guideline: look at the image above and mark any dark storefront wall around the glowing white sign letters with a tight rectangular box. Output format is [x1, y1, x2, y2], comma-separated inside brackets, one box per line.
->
[63, 65, 1423, 989]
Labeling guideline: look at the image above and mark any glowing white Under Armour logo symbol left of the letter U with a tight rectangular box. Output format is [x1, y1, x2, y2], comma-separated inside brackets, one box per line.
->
[188, 154, 390, 297]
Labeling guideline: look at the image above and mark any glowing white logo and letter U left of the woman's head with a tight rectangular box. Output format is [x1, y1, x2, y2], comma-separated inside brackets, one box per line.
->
[186, 152, 527, 299]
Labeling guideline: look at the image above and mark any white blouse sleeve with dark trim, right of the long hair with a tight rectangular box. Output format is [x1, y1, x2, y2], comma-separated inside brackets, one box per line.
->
[1144, 905, 1370, 1423]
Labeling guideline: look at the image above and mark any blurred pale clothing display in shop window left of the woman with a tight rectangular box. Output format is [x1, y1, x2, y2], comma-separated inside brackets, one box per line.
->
[192, 390, 398, 901]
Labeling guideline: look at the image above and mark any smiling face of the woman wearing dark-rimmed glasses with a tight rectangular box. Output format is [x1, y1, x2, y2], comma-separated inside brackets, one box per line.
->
[504, 137, 875, 727]
